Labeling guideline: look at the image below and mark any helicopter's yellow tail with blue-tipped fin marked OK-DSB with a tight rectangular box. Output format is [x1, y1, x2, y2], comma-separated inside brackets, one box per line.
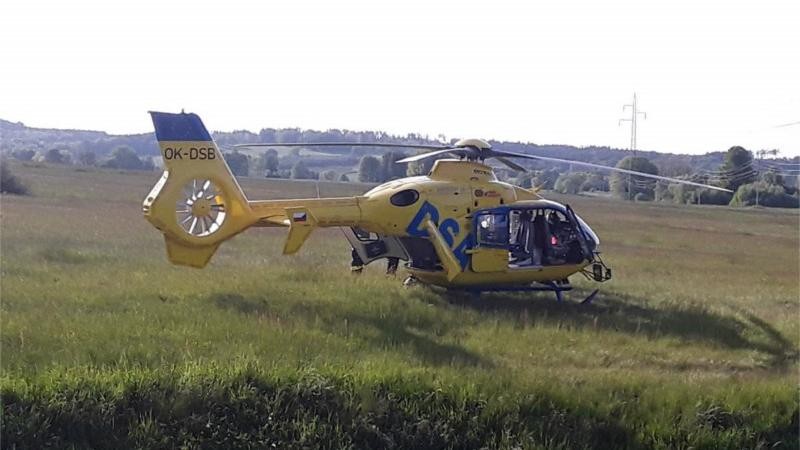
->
[142, 112, 361, 268]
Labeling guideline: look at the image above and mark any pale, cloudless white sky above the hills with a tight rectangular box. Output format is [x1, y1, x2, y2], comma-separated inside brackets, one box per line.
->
[0, 0, 800, 156]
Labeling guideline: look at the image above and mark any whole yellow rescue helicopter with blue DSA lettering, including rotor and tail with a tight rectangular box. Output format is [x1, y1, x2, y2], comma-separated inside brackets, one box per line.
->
[143, 112, 725, 302]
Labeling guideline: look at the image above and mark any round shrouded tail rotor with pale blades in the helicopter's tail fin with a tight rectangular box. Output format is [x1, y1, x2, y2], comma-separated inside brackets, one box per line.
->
[175, 178, 226, 237]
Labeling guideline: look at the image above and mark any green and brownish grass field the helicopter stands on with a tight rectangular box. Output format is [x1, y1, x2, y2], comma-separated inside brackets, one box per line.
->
[0, 165, 800, 448]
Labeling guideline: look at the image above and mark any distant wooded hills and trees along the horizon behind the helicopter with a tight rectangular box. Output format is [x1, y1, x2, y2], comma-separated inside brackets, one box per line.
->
[0, 120, 800, 207]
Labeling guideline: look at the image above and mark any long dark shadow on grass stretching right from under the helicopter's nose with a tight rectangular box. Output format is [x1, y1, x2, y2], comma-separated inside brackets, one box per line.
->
[440, 292, 799, 371]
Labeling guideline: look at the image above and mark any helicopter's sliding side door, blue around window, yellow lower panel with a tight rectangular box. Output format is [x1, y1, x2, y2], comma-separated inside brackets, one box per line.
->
[472, 208, 508, 272]
